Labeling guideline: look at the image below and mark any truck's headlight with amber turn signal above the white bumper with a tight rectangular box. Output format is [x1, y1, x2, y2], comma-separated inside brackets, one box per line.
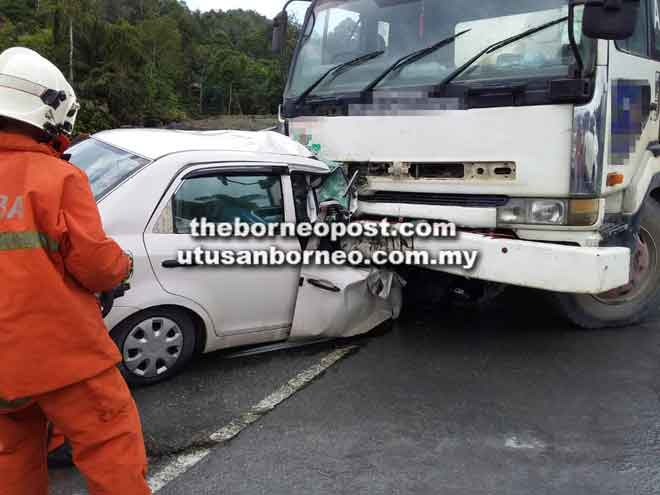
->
[497, 198, 600, 226]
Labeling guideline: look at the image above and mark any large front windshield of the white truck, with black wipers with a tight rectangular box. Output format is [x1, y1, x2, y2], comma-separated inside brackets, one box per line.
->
[287, 0, 592, 98]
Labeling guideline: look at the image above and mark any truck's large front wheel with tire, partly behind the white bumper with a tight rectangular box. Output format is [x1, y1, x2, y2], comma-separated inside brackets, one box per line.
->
[555, 199, 660, 329]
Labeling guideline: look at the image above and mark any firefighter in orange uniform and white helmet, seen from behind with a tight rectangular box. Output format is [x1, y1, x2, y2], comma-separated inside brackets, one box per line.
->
[0, 48, 151, 495]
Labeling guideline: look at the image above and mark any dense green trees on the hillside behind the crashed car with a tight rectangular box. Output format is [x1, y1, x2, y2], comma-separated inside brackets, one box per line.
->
[0, 0, 297, 132]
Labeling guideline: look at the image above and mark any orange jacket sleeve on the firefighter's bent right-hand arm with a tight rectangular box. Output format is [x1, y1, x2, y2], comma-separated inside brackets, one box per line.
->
[60, 170, 130, 292]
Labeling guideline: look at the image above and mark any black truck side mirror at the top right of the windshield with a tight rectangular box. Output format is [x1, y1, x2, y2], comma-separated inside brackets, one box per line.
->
[584, 0, 640, 40]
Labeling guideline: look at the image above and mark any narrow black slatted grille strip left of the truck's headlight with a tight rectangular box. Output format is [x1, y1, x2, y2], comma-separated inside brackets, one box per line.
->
[360, 191, 509, 208]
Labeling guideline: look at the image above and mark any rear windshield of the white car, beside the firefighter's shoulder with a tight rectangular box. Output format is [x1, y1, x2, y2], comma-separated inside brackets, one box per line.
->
[69, 138, 149, 200]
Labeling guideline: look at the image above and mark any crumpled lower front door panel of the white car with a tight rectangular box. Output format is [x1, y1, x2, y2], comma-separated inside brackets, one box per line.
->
[290, 266, 403, 340]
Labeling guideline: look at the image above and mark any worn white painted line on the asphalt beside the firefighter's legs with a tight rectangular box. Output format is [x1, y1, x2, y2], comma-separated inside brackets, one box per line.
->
[149, 345, 357, 493]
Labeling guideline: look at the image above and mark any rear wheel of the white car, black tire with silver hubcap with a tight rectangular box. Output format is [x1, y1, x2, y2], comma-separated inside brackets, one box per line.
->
[112, 308, 197, 386]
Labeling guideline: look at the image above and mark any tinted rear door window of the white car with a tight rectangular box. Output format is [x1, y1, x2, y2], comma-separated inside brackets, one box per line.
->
[172, 175, 284, 234]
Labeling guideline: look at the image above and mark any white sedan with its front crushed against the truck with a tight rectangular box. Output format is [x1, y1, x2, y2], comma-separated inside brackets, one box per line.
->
[64, 129, 400, 385]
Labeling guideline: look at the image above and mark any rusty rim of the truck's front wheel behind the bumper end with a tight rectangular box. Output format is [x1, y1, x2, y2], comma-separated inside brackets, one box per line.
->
[594, 228, 658, 305]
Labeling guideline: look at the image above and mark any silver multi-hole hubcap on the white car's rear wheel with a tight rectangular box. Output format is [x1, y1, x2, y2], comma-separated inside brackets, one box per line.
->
[122, 318, 183, 378]
